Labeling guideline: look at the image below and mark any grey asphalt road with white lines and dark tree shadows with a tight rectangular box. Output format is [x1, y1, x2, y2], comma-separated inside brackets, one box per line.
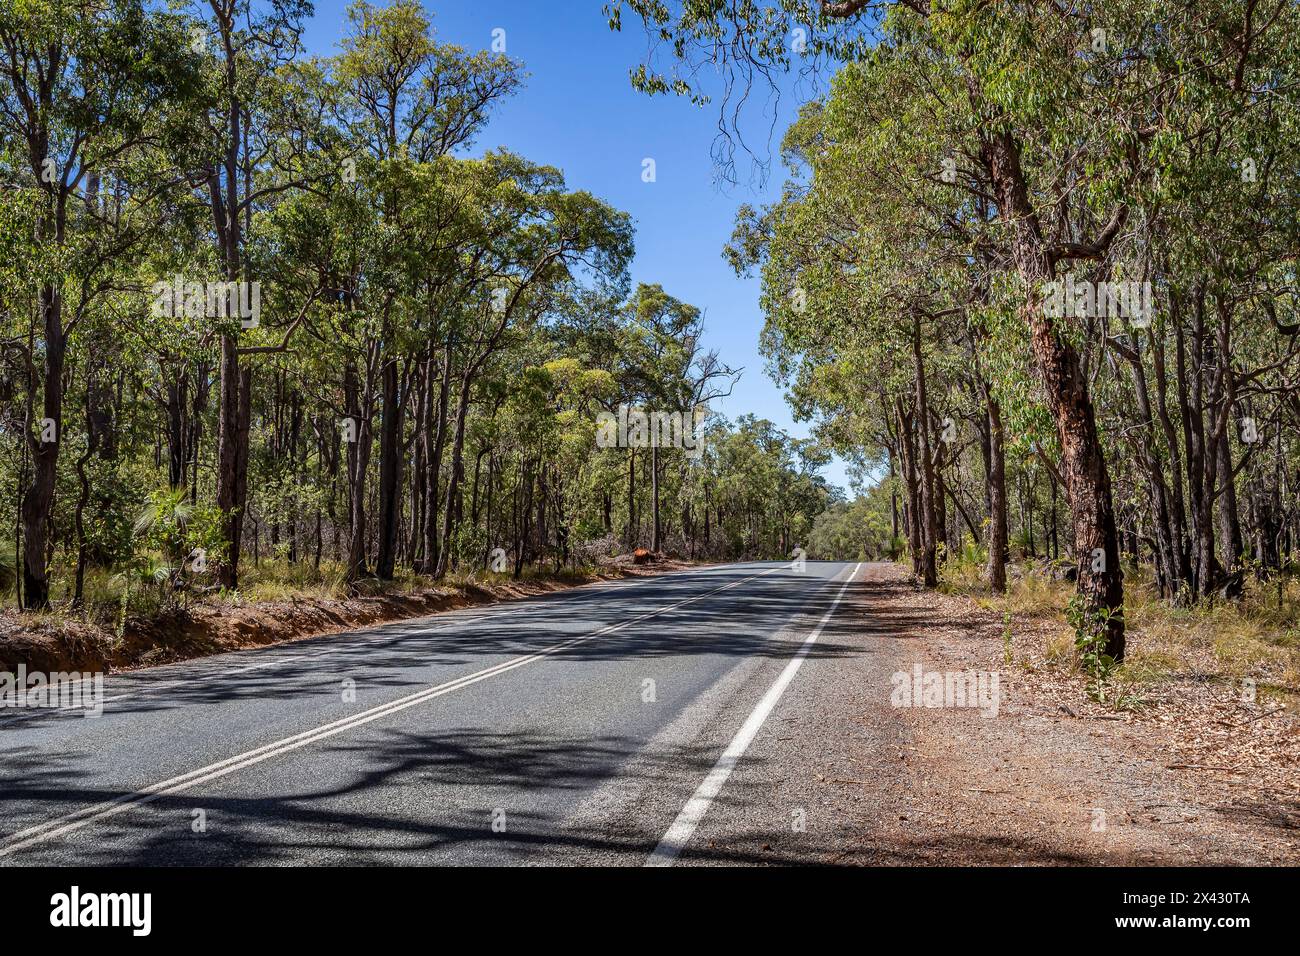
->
[0, 562, 873, 865]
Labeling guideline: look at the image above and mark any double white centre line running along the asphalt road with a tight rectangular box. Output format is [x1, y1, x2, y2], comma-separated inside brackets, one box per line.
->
[0, 564, 789, 858]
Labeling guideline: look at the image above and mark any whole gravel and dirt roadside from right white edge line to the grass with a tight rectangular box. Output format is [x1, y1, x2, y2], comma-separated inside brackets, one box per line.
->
[683, 564, 1300, 865]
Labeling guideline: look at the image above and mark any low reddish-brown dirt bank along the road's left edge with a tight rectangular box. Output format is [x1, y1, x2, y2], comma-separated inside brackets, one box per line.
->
[0, 557, 703, 672]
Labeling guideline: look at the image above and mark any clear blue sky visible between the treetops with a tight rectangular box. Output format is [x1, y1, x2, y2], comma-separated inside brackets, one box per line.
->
[306, 0, 848, 488]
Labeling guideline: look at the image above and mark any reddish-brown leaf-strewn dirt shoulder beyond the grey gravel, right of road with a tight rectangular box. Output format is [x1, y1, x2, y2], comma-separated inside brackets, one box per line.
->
[818, 564, 1300, 865]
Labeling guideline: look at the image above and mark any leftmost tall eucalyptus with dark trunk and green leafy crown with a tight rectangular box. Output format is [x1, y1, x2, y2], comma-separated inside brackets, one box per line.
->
[0, 0, 194, 607]
